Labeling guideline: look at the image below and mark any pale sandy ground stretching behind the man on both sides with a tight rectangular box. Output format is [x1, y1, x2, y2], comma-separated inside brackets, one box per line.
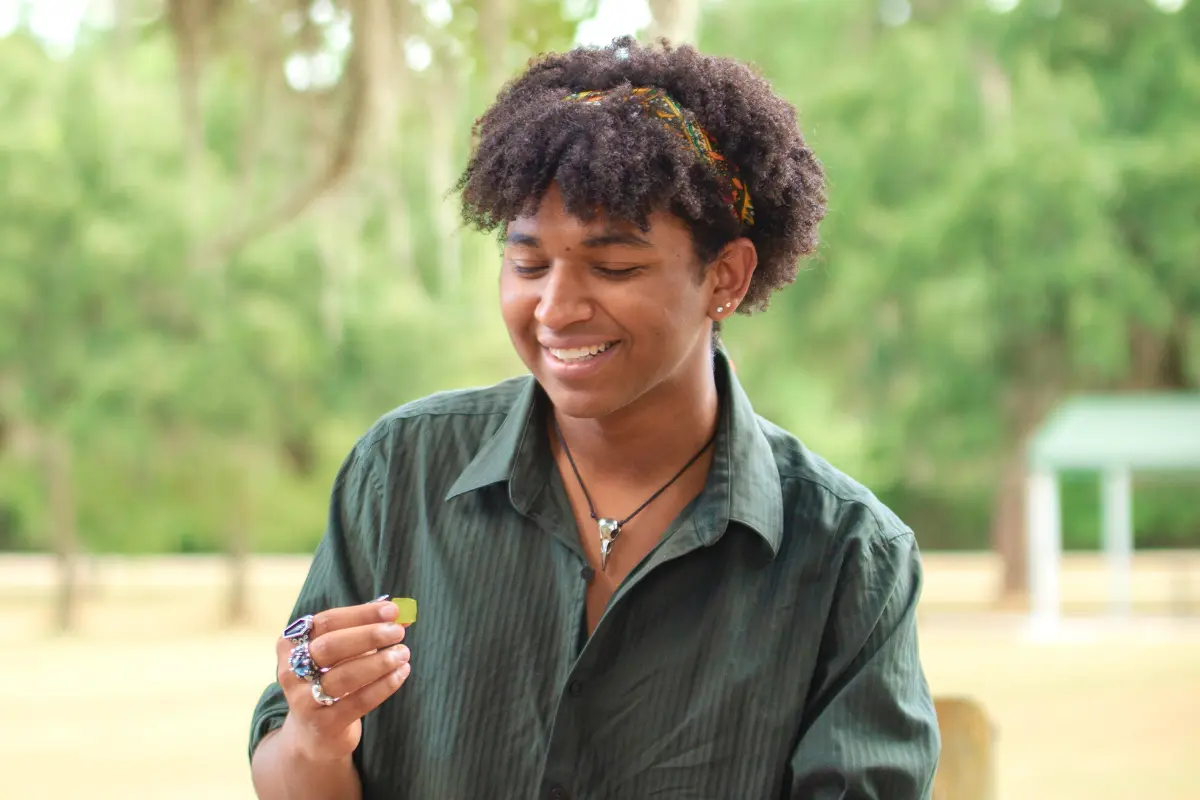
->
[0, 558, 1200, 800]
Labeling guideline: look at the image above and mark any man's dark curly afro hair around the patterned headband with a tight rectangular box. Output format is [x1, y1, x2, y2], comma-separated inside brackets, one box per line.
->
[457, 37, 826, 313]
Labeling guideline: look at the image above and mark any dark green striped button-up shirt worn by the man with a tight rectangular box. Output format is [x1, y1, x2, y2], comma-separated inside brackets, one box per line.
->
[250, 354, 940, 800]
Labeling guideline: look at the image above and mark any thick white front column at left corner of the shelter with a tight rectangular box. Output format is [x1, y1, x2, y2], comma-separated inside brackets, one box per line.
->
[1025, 468, 1062, 633]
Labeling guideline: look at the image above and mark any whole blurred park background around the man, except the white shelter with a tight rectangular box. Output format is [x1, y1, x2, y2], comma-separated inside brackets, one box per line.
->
[0, 0, 1200, 800]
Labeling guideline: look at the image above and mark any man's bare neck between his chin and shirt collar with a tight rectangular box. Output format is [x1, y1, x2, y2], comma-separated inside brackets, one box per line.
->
[553, 347, 719, 480]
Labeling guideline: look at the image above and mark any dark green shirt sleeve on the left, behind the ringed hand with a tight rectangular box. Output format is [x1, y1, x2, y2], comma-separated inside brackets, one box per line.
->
[250, 441, 380, 759]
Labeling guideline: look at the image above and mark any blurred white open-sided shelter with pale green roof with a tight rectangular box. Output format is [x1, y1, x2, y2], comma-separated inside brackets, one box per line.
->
[1026, 392, 1200, 634]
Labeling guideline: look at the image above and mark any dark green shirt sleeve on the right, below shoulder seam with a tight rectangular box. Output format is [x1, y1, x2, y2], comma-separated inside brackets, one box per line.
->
[791, 531, 941, 800]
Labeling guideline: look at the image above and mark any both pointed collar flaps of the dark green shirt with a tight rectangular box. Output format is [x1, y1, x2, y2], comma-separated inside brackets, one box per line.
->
[445, 350, 784, 555]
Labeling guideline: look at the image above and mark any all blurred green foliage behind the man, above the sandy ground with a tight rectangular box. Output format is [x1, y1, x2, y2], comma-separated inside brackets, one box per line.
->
[0, 0, 1200, 553]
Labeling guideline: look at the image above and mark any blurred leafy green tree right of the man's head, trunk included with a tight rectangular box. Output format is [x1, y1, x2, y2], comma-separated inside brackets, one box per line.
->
[710, 2, 1200, 596]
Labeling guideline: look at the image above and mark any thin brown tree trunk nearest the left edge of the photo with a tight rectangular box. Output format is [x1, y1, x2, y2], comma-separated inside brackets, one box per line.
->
[41, 433, 79, 633]
